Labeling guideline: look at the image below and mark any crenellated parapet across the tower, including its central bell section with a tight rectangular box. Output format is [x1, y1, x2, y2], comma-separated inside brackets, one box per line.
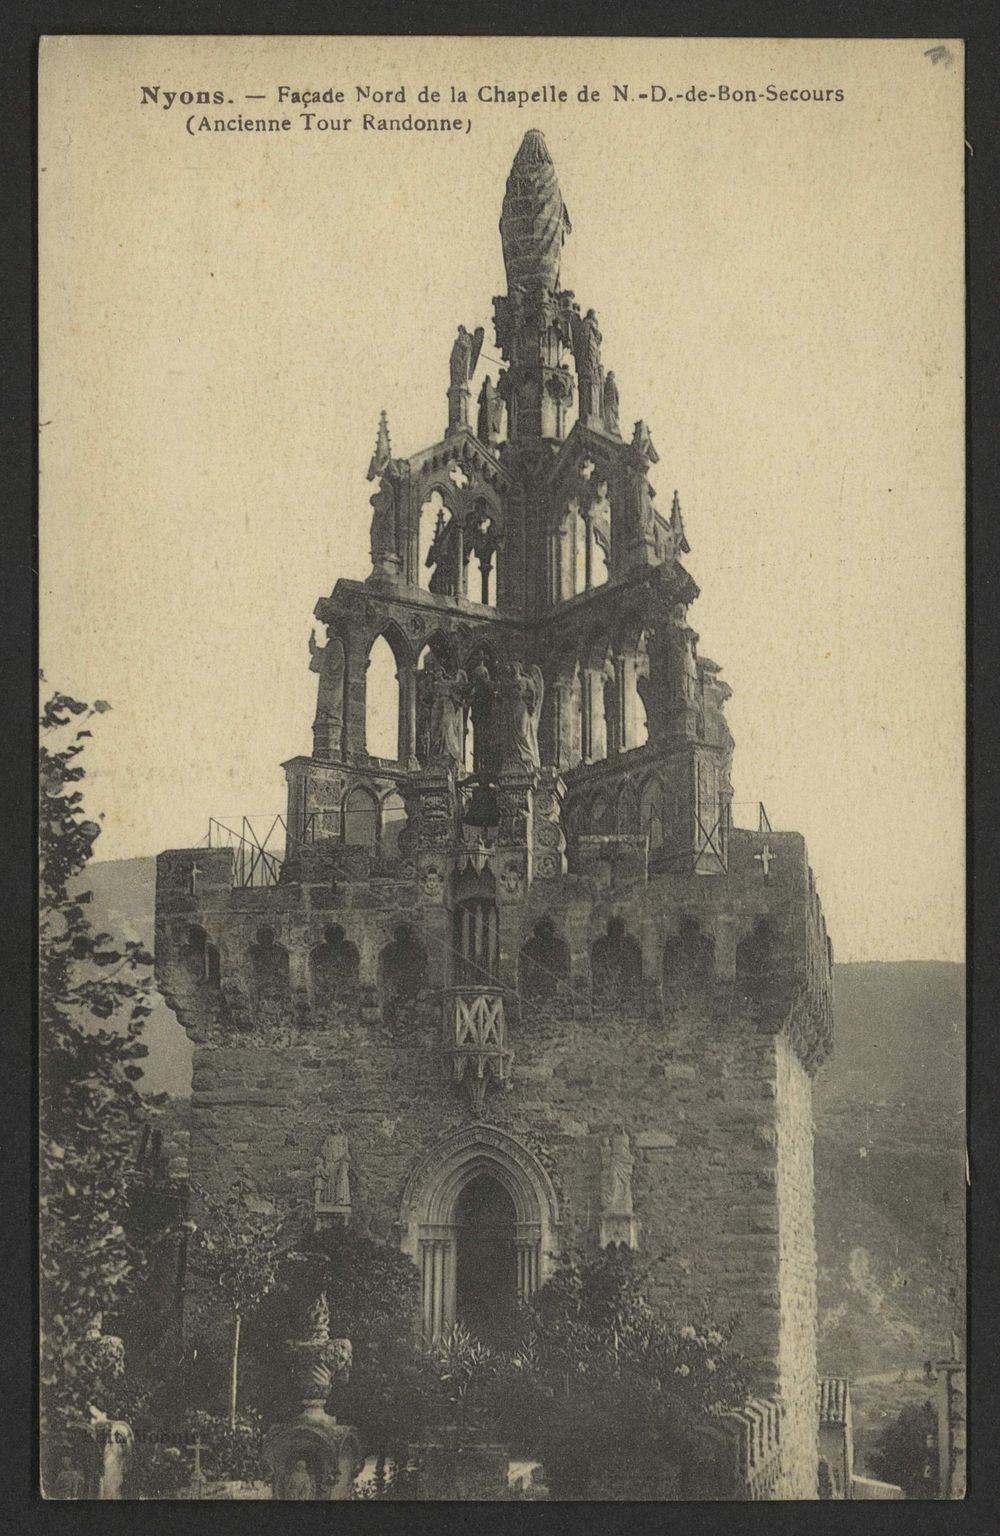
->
[157, 823, 833, 1075]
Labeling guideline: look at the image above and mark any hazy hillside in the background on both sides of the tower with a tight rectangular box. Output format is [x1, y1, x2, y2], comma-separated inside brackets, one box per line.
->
[80, 859, 965, 1400]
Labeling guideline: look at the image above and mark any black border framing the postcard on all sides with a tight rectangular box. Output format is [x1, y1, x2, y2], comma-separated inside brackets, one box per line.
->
[9, 0, 1000, 1536]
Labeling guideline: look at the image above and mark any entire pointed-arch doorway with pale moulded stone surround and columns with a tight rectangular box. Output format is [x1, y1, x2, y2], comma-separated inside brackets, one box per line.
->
[399, 1126, 558, 1339]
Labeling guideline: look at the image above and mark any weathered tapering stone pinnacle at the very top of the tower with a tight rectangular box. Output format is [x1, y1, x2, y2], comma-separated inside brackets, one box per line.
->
[499, 127, 571, 292]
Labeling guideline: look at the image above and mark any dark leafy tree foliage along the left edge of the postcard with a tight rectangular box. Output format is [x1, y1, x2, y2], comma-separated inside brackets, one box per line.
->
[38, 693, 152, 1428]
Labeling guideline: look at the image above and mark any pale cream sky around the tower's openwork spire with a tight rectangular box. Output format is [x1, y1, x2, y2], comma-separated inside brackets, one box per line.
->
[38, 37, 965, 960]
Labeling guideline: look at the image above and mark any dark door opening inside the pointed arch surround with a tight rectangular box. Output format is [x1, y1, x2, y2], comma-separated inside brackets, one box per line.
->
[455, 1174, 518, 1344]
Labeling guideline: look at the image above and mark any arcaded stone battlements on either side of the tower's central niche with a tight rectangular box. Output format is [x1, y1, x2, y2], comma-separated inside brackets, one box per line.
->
[157, 829, 833, 1071]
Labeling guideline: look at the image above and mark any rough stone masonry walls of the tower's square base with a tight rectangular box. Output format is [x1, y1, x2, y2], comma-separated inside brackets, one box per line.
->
[157, 834, 826, 1498]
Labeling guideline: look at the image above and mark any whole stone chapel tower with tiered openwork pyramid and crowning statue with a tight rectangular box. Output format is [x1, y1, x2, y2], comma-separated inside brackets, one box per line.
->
[157, 131, 831, 1498]
